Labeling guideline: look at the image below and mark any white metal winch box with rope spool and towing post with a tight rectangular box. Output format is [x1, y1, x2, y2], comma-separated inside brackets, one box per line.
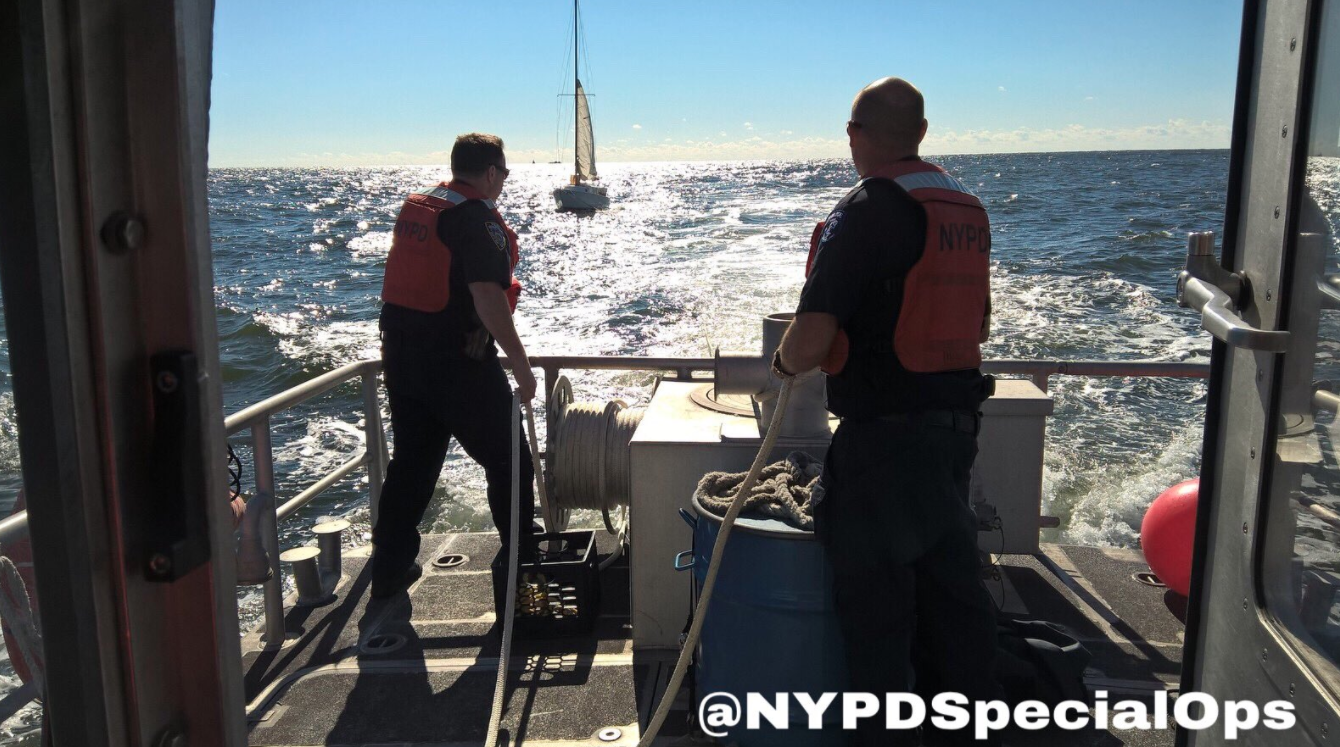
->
[536, 314, 1052, 649]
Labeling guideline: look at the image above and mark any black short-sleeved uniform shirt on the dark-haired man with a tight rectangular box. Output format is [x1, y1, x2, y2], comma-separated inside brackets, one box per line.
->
[381, 200, 512, 350]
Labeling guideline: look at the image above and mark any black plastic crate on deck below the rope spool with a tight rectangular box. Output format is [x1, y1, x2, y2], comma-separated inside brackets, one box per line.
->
[492, 531, 600, 638]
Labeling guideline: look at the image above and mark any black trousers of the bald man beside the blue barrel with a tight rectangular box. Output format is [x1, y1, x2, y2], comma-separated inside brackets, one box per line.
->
[815, 416, 1001, 747]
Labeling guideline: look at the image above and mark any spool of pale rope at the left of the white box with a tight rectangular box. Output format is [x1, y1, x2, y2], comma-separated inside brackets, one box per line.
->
[545, 377, 643, 532]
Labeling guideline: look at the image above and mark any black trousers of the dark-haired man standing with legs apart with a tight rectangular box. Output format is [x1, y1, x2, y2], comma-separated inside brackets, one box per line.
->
[373, 331, 535, 579]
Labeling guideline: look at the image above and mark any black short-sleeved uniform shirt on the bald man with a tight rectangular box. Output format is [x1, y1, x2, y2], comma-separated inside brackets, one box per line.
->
[796, 164, 986, 418]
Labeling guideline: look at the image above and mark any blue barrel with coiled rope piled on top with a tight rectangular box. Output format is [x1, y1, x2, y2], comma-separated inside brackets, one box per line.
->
[685, 499, 850, 747]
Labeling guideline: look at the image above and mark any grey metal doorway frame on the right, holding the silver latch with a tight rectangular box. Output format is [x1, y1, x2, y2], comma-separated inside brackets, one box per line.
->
[1178, 0, 1340, 746]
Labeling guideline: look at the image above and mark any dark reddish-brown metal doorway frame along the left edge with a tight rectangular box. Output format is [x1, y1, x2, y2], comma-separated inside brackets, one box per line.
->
[0, 0, 247, 746]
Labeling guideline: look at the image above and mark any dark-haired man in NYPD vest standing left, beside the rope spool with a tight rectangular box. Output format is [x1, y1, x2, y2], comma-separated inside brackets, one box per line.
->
[373, 133, 535, 598]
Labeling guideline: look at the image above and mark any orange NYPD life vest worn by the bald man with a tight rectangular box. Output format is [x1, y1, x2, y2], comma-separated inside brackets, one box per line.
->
[805, 161, 992, 374]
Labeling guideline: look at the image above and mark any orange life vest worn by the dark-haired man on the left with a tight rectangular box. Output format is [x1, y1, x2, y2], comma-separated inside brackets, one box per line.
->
[382, 181, 521, 312]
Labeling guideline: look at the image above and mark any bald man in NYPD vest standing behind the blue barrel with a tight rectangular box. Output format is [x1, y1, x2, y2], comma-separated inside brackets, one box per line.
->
[773, 78, 1000, 746]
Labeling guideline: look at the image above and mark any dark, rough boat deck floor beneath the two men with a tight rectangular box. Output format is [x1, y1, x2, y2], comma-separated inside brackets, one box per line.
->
[243, 532, 1182, 747]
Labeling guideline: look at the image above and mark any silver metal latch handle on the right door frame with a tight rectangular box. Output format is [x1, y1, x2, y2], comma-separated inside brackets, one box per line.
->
[1177, 231, 1289, 353]
